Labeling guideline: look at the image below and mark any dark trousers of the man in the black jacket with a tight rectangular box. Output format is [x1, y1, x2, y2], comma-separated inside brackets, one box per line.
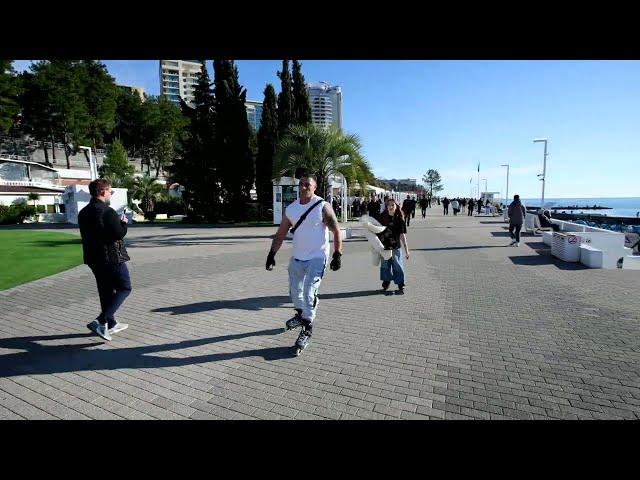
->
[89, 263, 131, 328]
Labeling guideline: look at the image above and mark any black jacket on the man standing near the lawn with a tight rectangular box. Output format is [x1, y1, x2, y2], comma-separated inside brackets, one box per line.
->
[78, 198, 129, 265]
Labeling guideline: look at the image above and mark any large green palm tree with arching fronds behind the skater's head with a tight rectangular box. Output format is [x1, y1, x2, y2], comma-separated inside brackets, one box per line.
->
[274, 124, 374, 197]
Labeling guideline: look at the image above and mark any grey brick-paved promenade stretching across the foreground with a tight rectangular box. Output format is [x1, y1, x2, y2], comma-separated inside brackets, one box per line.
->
[0, 208, 640, 419]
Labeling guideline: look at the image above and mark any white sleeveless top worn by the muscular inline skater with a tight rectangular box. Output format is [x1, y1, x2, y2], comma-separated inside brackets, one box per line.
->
[285, 195, 329, 260]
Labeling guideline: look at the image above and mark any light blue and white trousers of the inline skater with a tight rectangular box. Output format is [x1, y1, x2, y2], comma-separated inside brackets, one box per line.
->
[289, 257, 327, 323]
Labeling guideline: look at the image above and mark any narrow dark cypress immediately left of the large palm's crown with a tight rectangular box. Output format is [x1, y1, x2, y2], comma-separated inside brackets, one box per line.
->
[256, 84, 278, 209]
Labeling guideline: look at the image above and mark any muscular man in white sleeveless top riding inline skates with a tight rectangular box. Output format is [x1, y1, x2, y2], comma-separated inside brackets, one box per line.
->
[266, 176, 342, 354]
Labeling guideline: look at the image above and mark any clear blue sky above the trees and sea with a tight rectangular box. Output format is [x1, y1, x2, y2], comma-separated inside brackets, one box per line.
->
[14, 60, 640, 198]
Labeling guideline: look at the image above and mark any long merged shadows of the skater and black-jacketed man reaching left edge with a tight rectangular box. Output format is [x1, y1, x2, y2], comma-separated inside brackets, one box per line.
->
[0, 328, 294, 378]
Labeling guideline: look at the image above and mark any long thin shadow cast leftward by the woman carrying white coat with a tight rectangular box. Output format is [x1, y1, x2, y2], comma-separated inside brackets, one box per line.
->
[151, 290, 380, 315]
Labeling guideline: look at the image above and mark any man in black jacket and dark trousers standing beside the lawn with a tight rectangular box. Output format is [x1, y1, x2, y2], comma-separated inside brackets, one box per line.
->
[78, 179, 131, 340]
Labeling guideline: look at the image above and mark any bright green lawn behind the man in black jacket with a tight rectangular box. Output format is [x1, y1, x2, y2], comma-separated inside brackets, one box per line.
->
[0, 230, 82, 290]
